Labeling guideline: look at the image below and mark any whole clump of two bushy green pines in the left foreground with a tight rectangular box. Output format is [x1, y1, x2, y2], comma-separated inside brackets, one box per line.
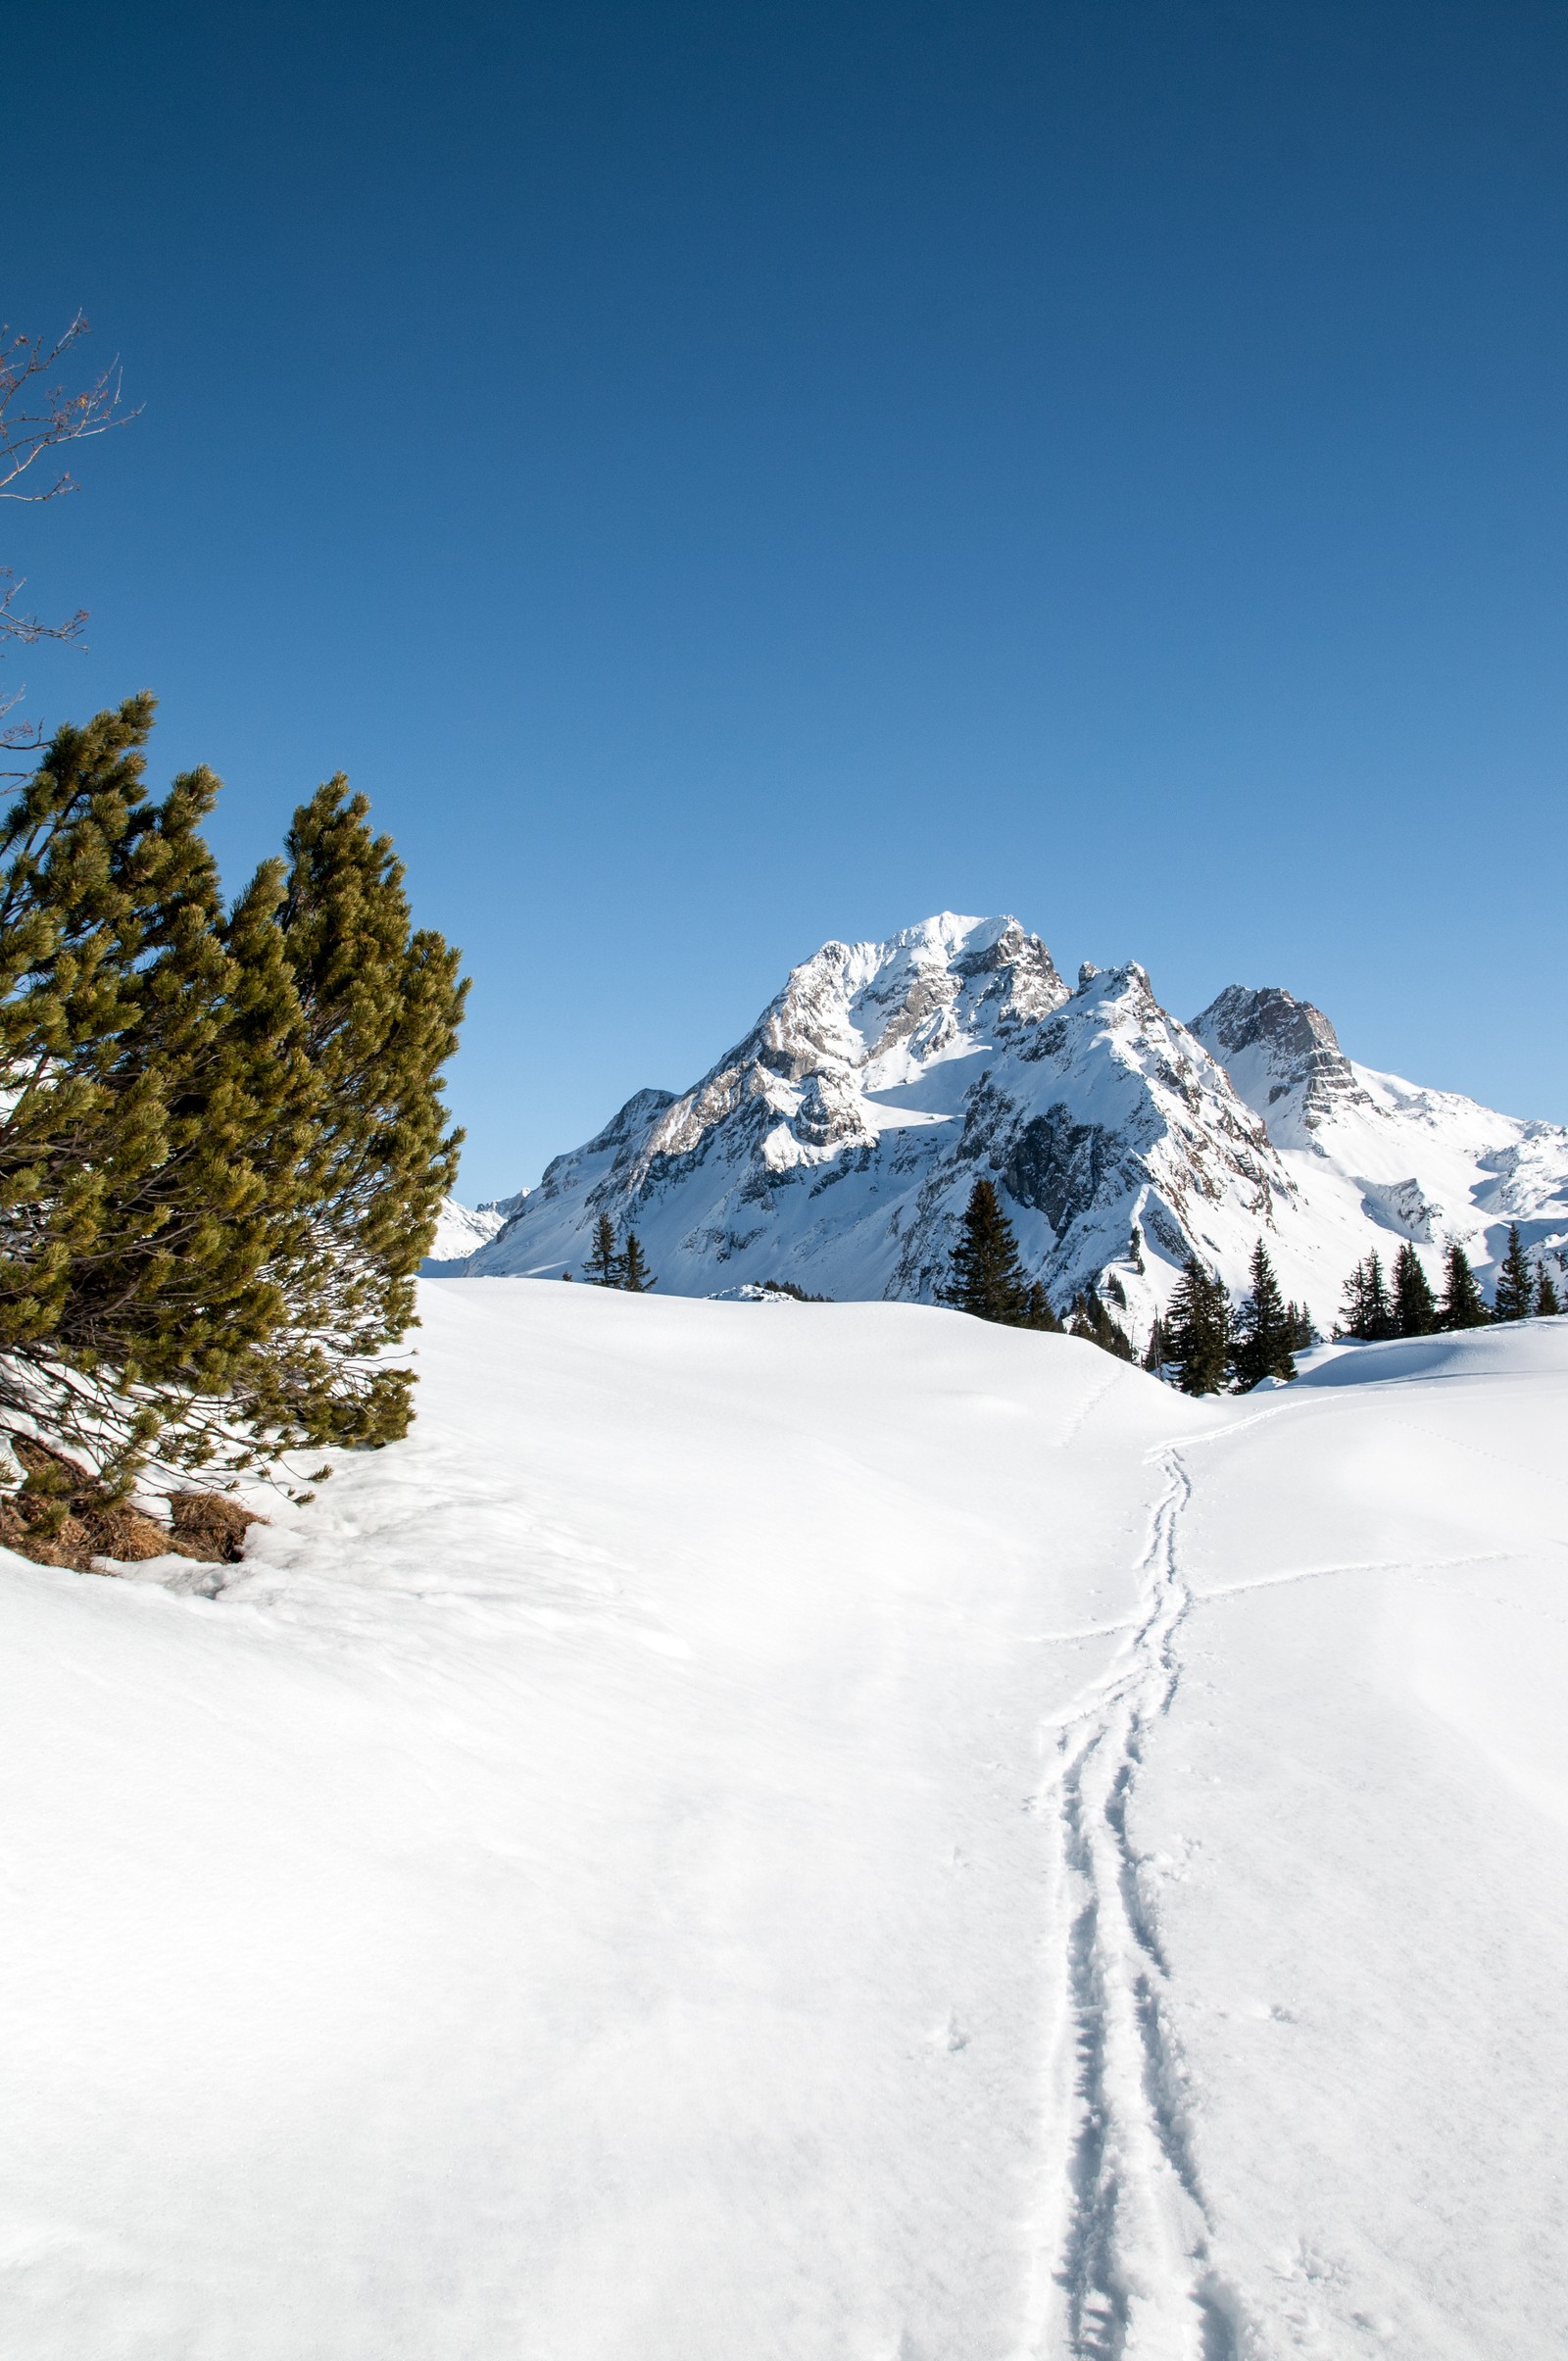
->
[0, 697, 467, 1485]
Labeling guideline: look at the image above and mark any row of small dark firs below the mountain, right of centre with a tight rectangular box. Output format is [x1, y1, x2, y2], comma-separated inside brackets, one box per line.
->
[938, 1181, 1563, 1393]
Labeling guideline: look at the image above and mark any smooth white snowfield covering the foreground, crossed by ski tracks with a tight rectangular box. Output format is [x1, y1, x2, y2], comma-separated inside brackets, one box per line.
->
[0, 1280, 1568, 2361]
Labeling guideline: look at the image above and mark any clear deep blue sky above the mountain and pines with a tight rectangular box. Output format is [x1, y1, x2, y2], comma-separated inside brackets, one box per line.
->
[0, 0, 1568, 1197]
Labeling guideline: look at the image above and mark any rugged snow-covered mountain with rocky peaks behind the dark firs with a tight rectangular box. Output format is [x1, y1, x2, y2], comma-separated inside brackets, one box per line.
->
[453, 911, 1568, 1336]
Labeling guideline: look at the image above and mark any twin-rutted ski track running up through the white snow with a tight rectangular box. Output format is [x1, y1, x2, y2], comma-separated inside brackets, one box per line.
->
[1020, 1448, 1245, 2361]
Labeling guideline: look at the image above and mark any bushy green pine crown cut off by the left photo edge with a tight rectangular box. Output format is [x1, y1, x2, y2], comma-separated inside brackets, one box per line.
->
[0, 697, 317, 1476]
